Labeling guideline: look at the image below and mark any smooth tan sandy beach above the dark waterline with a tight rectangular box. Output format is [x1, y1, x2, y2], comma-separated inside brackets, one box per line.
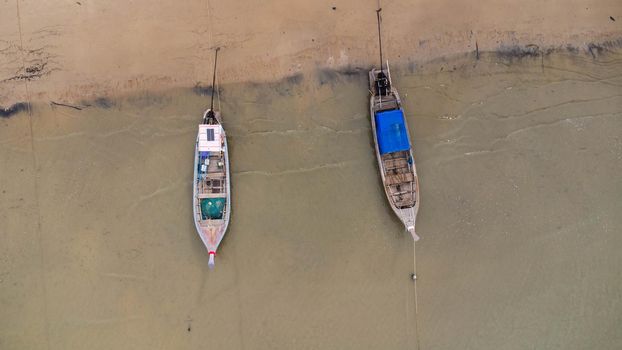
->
[0, 0, 622, 107]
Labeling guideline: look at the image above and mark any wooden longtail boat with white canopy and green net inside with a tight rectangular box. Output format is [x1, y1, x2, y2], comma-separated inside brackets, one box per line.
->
[192, 50, 231, 268]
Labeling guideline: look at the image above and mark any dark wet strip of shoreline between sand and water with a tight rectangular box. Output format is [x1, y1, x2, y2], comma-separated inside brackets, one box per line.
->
[0, 37, 622, 118]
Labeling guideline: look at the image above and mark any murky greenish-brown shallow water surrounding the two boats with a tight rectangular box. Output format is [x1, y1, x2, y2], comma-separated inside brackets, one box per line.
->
[0, 53, 622, 349]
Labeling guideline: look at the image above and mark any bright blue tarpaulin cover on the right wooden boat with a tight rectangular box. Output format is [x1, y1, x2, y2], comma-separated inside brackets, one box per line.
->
[376, 109, 410, 154]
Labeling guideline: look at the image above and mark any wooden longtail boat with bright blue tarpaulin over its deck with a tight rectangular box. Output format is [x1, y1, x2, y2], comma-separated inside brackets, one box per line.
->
[369, 10, 419, 241]
